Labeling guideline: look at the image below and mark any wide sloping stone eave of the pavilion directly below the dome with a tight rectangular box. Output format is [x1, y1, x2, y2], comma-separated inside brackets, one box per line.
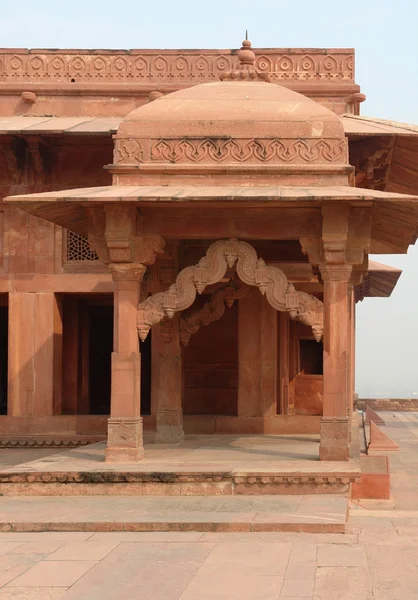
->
[5, 185, 418, 254]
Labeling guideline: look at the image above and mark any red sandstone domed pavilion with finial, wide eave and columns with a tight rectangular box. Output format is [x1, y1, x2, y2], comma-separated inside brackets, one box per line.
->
[8, 40, 418, 462]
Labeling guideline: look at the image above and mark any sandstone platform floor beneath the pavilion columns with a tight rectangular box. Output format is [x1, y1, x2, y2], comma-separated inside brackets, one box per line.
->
[0, 434, 359, 474]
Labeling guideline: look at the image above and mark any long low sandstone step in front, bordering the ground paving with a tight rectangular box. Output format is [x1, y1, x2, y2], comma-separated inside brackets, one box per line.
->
[0, 494, 348, 533]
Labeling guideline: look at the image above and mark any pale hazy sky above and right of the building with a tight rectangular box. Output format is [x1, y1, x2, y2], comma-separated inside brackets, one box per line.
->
[0, 0, 418, 395]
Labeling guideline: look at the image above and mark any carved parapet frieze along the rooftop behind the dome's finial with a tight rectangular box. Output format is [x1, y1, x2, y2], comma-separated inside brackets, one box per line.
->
[0, 49, 354, 87]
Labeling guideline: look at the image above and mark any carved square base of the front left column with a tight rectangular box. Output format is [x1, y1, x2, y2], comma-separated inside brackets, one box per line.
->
[106, 417, 144, 463]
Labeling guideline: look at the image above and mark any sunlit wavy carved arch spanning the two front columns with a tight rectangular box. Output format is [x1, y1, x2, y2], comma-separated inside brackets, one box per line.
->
[137, 239, 324, 341]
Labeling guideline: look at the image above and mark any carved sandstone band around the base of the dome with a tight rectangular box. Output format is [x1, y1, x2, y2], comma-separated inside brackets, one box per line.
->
[114, 137, 348, 164]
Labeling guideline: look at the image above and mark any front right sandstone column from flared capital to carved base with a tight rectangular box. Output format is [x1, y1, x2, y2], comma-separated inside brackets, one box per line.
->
[319, 264, 352, 460]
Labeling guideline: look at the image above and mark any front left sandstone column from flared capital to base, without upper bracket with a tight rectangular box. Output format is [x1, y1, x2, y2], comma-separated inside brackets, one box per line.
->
[106, 263, 146, 462]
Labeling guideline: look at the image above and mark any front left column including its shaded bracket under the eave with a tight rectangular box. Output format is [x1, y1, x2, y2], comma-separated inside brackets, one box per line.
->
[86, 203, 164, 462]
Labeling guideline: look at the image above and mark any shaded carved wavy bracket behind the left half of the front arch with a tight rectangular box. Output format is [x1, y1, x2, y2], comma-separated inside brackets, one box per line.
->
[180, 281, 249, 346]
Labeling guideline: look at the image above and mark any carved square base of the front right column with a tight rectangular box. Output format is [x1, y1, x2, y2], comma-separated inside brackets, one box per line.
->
[319, 417, 350, 460]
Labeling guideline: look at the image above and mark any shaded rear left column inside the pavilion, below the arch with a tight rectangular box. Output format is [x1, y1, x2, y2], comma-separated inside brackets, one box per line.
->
[155, 314, 184, 444]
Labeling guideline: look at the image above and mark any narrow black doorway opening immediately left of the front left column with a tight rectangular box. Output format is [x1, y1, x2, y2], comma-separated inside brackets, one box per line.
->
[88, 306, 113, 415]
